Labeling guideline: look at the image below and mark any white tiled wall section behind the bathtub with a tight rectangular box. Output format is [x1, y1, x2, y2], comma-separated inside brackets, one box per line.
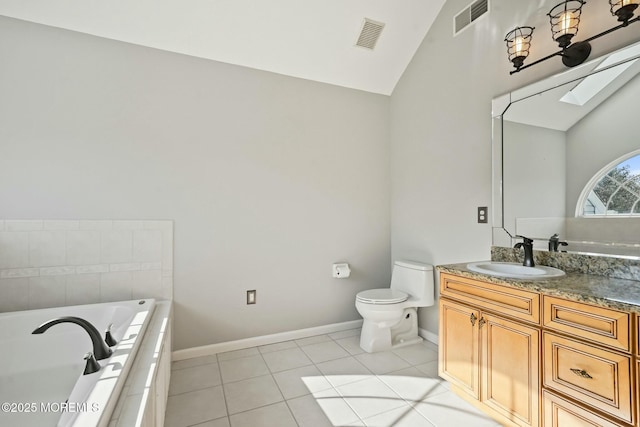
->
[0, 220, 173, 312]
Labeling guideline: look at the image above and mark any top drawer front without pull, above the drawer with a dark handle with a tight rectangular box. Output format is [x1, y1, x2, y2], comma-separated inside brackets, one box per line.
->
[542, 295, 631, 352]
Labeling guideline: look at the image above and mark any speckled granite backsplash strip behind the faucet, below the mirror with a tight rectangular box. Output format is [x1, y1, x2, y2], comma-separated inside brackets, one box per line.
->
[491, 246, 640, 281]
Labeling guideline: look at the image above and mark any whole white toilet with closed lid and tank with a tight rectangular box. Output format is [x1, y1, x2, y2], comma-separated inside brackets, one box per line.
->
[356, 261, 434, 353]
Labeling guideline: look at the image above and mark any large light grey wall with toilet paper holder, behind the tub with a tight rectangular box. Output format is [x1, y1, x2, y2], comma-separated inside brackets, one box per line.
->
[0, 18, 390, 349]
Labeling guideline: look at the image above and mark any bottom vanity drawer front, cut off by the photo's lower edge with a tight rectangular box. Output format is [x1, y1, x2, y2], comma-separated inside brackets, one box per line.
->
[542, 390, 623, 427]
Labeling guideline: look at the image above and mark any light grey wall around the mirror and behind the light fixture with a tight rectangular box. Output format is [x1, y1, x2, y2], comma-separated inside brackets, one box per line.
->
[384, 0, 638, 333]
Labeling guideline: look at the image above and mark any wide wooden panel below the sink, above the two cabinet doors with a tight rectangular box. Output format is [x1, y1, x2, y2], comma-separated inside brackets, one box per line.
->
[440, 273, 540, 324]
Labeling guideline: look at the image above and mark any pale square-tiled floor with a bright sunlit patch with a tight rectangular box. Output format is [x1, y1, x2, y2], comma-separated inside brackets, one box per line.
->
[165, 329, 499, 427]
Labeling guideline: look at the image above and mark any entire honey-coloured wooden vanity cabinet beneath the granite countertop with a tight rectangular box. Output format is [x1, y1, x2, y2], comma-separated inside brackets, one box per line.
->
[439, 272, 640, 427]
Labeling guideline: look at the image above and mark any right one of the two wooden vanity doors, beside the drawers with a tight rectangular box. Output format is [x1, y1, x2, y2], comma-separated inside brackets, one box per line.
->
[479, 313, 541, 426]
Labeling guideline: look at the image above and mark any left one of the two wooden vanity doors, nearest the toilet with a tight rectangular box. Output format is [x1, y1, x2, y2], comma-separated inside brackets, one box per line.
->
[438, 298, 480, 399]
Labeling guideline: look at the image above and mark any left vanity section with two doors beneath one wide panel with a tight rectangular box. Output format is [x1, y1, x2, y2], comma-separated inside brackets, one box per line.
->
[439, 274, 540, 426]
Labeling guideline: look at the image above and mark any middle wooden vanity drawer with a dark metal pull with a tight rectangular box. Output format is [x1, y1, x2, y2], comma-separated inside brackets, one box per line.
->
[543, 332, 635, 423]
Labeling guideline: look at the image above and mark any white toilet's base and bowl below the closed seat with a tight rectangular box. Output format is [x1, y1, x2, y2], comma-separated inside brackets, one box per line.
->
[360, 307, 422, 353]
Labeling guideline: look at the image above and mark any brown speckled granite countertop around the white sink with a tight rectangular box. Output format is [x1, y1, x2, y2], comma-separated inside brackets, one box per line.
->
[436, 263, 640, 313]
